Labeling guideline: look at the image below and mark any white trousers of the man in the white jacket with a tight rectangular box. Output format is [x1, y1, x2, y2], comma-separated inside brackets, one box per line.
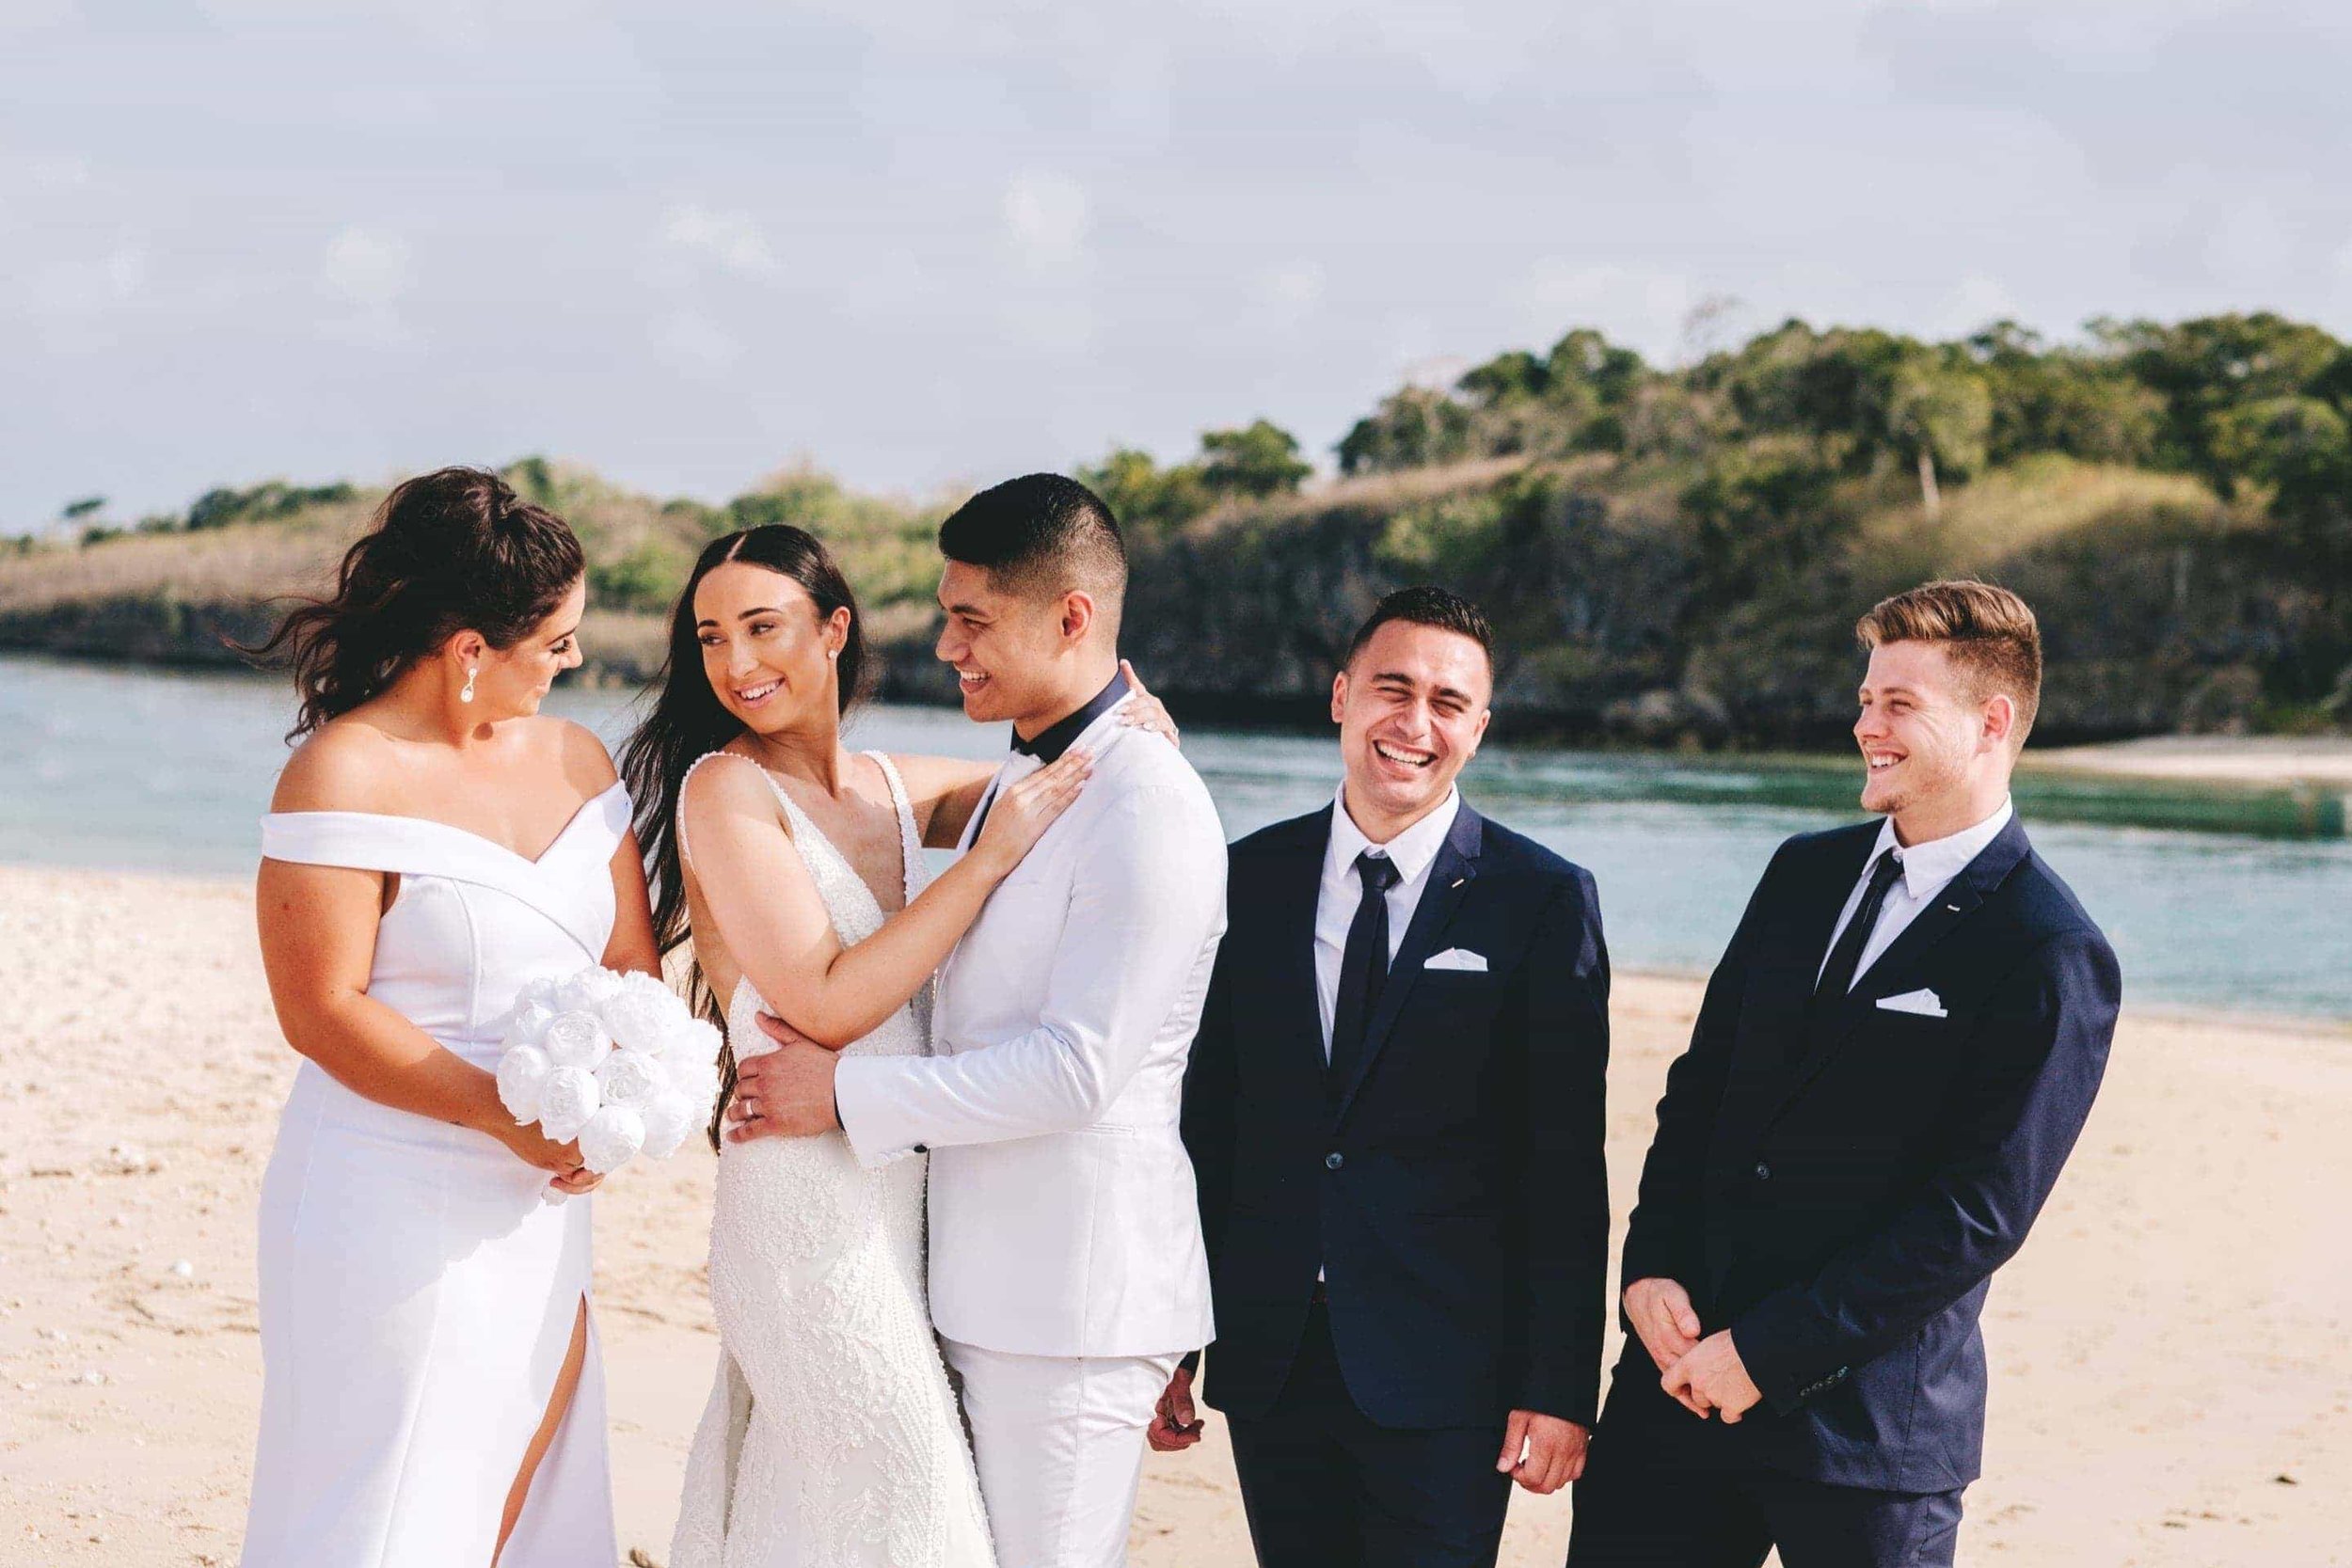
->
[944, 1340, 1181, 1568]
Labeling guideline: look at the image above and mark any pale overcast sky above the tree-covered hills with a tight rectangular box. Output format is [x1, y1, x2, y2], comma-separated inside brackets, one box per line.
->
[0, 0, 2352, 529]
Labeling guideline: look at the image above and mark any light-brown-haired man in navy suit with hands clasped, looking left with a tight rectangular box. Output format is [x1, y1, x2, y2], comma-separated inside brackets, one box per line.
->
[1569, 583, 2122, 1568]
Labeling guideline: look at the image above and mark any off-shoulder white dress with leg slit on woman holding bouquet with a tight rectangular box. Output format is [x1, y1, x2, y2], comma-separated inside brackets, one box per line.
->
[245, 785, 630, 1568]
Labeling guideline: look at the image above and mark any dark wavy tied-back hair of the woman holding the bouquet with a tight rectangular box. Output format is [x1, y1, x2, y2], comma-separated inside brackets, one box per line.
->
[238, 467, 586, 740]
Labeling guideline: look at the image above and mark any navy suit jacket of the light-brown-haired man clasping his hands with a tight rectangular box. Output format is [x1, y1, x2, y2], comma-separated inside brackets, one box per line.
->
[1604, 820, 2122, 1491]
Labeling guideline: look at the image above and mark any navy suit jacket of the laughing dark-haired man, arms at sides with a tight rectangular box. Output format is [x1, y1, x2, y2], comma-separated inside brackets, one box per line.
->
[1184, 804, 1609, 1427]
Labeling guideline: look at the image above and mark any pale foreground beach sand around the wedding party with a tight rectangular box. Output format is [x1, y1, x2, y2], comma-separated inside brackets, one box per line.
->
[0, 870, 2352, 1568]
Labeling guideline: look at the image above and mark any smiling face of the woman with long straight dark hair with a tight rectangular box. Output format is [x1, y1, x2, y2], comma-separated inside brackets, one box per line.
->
[694, 562, 850, 736]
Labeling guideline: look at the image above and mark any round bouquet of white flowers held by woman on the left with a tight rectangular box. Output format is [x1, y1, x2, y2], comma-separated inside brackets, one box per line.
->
[499, 969, 720, 1176]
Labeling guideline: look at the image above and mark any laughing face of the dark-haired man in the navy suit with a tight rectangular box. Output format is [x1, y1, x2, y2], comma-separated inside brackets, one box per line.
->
[1331, 621, 1494, 844]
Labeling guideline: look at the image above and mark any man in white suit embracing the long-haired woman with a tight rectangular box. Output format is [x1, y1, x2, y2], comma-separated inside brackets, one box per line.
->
[737, 475, 1226, 1568]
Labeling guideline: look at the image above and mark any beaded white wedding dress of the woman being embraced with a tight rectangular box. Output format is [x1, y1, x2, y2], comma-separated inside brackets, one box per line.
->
[671, 752, 995, 1568]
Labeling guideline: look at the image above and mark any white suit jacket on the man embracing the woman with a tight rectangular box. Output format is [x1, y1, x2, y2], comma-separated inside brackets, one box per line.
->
[835, 710, 1226, 1356]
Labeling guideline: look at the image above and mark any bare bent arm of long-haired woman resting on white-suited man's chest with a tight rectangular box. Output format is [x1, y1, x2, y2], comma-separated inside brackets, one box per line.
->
[680, 752, 1091, 1049]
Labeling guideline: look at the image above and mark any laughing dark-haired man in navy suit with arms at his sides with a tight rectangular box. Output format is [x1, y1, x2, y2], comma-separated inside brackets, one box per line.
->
[1152, 588, 1609, 1568]
